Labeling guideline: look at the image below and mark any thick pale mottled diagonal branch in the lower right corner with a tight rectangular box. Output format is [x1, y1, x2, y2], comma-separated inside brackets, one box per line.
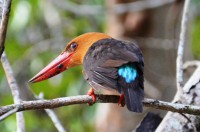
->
[156, 66, 200, 132]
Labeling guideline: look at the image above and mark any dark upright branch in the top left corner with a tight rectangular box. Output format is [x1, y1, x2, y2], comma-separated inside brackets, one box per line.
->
[0, 0, 12, 58]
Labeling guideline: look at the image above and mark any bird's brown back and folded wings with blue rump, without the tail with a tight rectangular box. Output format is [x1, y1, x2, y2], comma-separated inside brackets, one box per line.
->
[83, 39, 143, 92]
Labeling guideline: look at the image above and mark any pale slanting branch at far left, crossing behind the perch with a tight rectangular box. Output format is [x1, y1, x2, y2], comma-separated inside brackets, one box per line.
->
[1, 52, 25, 132]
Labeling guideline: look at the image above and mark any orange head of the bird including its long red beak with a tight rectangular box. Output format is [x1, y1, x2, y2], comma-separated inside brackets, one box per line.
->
[29, 32, 110, 83]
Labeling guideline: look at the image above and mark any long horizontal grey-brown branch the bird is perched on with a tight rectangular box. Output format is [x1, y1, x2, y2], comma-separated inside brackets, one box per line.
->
[0, 94, 200, 116]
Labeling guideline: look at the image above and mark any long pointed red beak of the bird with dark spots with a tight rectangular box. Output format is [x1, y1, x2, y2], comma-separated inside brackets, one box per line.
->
[29, 51, 72, 83]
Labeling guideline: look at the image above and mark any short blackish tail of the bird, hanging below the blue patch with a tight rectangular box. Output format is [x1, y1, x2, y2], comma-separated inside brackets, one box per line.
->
[123, 87, 144, 113]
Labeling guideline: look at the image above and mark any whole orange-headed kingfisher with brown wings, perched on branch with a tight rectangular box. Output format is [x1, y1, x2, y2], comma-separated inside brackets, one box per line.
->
[29, 32, 144, 113]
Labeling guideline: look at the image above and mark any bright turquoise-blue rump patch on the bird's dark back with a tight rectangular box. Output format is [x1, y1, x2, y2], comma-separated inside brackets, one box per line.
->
[118, 64, 137, 83]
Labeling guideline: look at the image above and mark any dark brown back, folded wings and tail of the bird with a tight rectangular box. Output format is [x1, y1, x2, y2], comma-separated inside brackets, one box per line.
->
[83, 38, 144, 112]
